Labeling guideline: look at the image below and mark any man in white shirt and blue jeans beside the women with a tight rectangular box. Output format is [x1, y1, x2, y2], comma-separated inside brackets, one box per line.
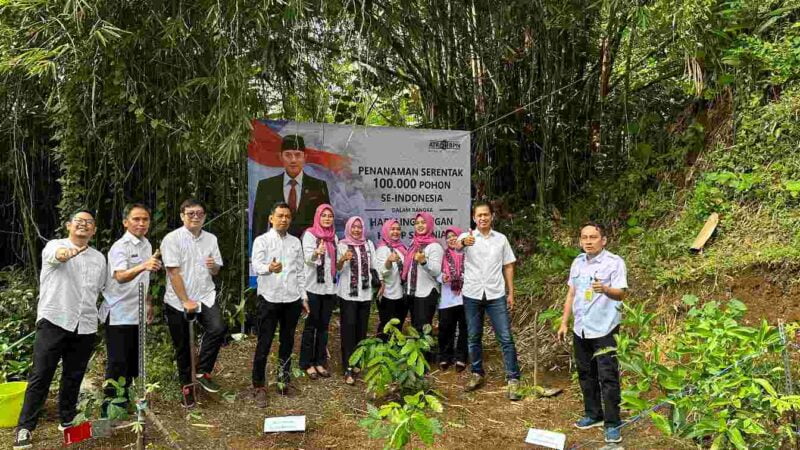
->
[458, 202, 522, 400]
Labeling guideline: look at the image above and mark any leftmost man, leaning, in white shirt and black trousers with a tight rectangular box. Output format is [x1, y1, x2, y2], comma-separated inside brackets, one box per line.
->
[14, 210, 106, 449]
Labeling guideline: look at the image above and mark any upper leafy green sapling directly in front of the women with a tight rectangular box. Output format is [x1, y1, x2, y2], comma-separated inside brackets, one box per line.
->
[350, 319, 434, 396]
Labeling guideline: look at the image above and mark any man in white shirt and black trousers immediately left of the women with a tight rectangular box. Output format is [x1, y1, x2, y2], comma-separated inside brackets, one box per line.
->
[252, 202, 308, 408]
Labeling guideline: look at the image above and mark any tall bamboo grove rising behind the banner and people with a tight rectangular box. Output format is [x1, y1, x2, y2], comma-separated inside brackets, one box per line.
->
[0, 0, 798, 320]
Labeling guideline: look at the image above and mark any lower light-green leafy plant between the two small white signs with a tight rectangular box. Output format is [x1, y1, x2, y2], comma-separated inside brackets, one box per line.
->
[358, 391, 442, 449]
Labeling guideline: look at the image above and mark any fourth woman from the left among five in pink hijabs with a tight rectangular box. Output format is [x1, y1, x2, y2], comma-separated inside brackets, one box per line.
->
[403, 212, 444, 333]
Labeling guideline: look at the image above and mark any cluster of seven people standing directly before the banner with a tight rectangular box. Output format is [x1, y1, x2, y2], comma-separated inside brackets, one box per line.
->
[251, 202, 520, 407]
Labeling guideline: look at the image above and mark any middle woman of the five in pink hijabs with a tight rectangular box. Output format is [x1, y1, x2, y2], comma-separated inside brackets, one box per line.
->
[375, 219, 408, 341]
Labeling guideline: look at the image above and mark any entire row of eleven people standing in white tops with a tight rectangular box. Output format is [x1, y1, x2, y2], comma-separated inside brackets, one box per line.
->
[9, 199, 627, 449]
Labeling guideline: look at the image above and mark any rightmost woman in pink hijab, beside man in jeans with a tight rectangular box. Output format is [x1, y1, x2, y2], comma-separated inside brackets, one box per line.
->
[439, 227, 467, 372]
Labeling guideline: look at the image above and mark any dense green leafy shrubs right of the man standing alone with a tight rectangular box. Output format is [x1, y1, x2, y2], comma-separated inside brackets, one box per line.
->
[617, 295, 800, 448]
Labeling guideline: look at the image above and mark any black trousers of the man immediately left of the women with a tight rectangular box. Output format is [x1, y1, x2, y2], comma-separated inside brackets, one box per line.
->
[253, 295, 303, 387]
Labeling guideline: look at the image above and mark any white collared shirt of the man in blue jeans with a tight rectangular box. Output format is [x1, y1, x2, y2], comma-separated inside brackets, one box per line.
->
[458, 230, 517, 300]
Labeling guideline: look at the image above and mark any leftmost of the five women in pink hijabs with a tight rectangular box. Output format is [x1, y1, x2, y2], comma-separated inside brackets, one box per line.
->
[300, 203, 338, 380]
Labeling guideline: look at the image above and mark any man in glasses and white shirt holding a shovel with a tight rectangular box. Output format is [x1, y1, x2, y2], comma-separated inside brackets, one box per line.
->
[161, 199, 227, 408]
